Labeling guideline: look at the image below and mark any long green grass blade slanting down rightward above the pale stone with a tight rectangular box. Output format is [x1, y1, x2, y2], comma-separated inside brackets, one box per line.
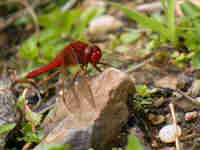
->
[108, 2, 170, 40]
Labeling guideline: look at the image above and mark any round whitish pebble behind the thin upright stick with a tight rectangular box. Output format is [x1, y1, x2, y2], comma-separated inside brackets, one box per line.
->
[159, 124, 182, 143]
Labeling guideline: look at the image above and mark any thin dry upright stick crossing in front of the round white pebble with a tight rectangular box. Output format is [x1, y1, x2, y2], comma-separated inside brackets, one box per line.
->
[169, 103, 180, 150]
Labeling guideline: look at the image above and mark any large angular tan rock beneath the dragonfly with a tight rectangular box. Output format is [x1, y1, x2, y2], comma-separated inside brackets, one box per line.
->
[38, 68, 135, 150]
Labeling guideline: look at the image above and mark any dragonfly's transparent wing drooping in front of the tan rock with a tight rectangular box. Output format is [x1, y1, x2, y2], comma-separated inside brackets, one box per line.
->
[61, 45, 96, 116]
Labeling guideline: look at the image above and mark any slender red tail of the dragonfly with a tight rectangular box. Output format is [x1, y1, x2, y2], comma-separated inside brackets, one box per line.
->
[26, 61, 61, 78]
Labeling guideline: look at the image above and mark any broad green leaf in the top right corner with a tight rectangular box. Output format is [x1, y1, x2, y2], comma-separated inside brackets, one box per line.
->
[180, 1, 200, 18]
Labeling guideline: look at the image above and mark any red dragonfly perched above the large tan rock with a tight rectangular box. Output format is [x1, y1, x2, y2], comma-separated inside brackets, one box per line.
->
[25, 41, 110, 111]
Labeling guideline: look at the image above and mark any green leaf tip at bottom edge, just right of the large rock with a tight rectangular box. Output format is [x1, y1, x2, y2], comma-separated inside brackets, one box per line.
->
[125, 136, 144, 150]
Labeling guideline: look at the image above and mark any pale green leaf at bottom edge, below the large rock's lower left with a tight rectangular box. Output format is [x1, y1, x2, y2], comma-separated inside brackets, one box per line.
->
[33, 144, 71, 150]
